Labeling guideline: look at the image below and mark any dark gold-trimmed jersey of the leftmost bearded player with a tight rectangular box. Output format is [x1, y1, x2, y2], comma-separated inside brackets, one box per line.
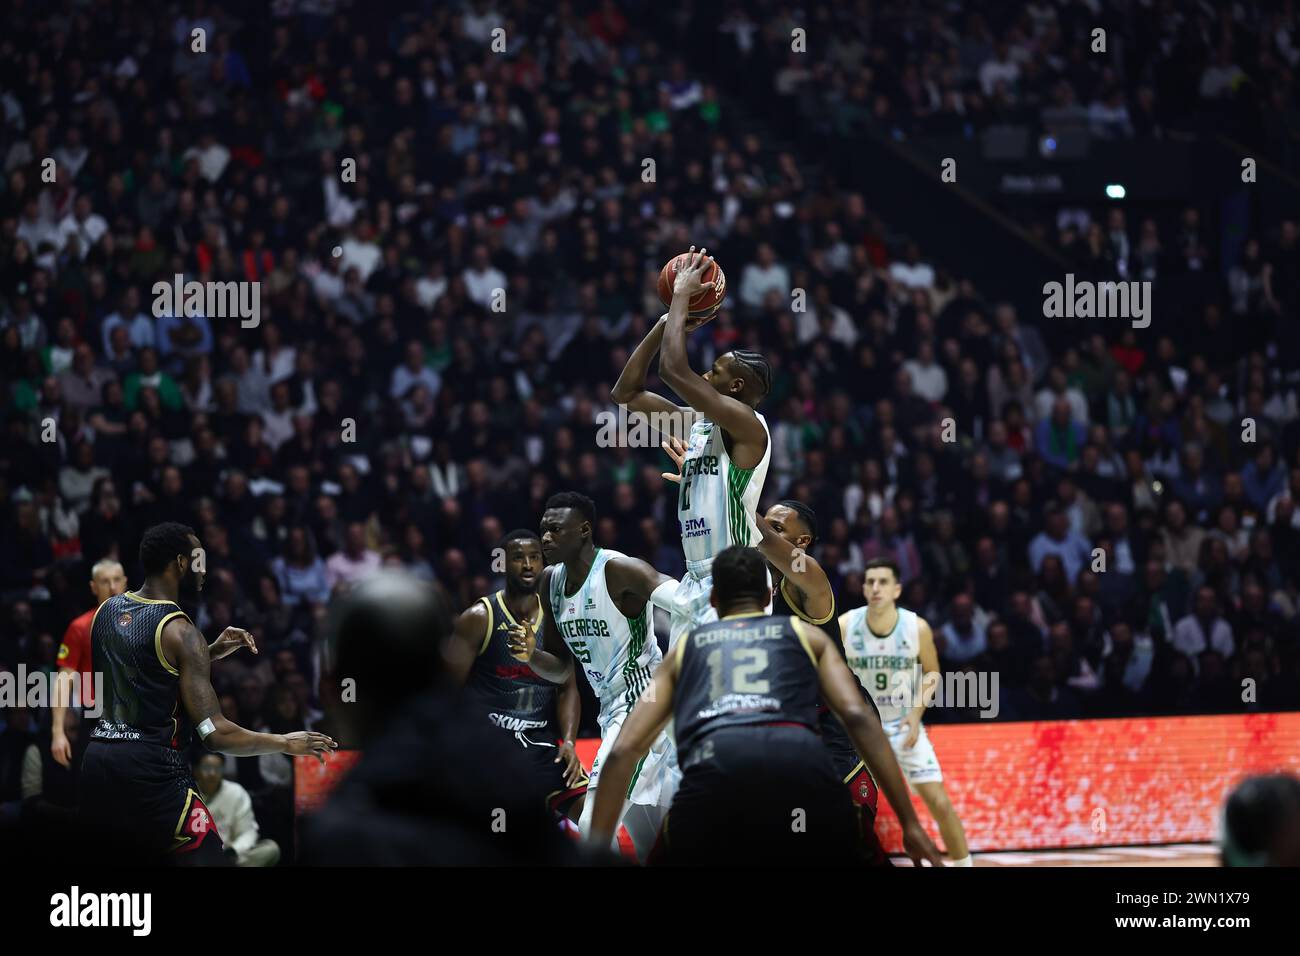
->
[90, 592, 194, 750]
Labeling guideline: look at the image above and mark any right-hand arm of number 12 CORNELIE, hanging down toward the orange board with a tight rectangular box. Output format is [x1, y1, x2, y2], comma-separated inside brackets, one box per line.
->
[794, 620, 944, 866]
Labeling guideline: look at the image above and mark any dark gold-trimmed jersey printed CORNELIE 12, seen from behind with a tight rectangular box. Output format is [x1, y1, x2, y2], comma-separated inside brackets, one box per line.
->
[672, 614, 818, 767]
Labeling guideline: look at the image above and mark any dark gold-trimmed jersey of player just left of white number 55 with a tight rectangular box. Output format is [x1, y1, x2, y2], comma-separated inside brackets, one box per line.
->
[465, 591, 559, 743]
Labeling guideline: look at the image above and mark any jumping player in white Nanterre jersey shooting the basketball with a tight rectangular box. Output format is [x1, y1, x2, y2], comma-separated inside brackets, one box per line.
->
[610, 246, 772, 646]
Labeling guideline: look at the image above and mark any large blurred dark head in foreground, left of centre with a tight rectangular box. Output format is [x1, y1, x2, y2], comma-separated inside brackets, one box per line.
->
[326, 571, 451, 744]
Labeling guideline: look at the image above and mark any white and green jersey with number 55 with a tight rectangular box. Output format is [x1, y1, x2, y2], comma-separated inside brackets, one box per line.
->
[550, 548, 663, 714]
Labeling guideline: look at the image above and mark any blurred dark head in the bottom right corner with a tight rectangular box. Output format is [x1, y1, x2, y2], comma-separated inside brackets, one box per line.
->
[1222, 774, 1300, 866]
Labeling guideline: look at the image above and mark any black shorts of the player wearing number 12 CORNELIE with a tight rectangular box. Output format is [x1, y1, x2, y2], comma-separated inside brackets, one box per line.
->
[653, 724, 865, 866]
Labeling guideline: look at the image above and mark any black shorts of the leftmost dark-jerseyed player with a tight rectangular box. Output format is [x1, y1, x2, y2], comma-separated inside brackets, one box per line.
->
[79, 740, 225, 866]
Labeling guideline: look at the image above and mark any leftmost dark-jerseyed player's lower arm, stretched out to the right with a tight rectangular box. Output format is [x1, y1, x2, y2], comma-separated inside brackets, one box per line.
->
[163, 618, 338, 763]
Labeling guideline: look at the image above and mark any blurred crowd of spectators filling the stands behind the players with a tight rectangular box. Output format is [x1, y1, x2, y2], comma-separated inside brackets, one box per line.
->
[0, 0, 1300, 858]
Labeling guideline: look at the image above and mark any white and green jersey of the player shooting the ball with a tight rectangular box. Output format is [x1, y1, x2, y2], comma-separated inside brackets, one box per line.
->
[677, 412, 772, 576]
